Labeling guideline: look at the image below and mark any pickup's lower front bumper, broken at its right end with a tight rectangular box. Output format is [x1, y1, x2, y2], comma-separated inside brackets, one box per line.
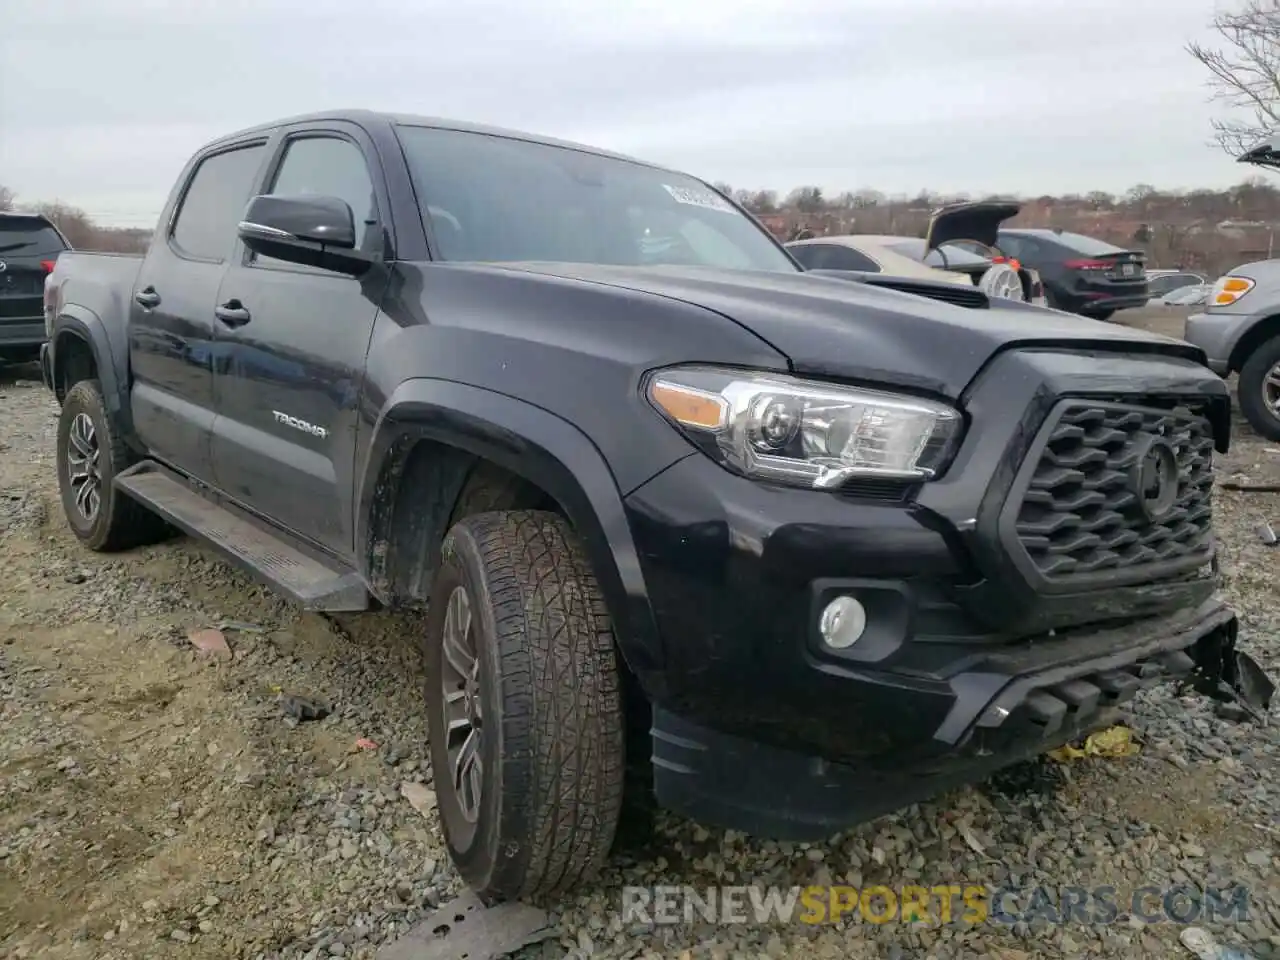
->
[652, 599, 1275, 841]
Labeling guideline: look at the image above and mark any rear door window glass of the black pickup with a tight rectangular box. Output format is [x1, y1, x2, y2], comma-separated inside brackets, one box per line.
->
[172, 143, 262, 261]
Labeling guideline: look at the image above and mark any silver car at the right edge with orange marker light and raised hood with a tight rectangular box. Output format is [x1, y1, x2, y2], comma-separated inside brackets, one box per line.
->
[1183, 136, 1280, 440]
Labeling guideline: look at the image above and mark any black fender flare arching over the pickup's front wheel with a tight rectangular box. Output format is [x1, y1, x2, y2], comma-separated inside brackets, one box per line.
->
[356, 378, 664, 698]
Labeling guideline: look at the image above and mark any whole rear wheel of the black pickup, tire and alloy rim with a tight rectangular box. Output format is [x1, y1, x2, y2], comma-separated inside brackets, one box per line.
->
[58, 380, 172, 553]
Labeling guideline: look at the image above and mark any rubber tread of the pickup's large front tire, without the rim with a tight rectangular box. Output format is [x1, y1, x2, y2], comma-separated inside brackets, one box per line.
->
[425, 511, 626, 904]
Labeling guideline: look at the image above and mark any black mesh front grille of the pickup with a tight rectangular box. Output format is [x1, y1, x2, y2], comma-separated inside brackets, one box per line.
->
[1016, 401, 1213, 582]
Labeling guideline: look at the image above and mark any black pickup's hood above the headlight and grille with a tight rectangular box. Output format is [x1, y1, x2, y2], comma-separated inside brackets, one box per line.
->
[488, 264, 1203, 399]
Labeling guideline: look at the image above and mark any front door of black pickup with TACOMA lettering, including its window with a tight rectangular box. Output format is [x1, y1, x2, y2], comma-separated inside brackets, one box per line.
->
[212, 127, 385, 557]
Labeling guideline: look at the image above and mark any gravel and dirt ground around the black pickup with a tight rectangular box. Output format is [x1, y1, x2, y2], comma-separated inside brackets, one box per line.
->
[0, 310, 1280, 960]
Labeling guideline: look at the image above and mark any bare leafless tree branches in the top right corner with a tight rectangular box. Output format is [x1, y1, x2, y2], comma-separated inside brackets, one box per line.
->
[1187, 0, 1280, 156]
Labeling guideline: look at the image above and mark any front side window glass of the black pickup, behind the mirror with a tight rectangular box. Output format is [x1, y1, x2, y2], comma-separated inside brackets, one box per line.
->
[252, 137, 378, 264]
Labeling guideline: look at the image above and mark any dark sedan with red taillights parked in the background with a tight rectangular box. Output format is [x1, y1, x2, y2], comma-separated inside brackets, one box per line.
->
[1000, 229, 1151, 320]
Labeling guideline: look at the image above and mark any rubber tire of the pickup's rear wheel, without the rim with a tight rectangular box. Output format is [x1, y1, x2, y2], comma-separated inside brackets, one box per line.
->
[56, 380, 174, 553]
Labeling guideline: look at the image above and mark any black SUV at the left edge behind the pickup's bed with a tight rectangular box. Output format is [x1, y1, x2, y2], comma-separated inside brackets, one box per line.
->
[0, 212, 70, 361]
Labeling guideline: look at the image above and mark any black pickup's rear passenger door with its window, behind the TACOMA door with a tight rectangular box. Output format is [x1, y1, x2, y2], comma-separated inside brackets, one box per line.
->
[129, 138, 266, 483]
